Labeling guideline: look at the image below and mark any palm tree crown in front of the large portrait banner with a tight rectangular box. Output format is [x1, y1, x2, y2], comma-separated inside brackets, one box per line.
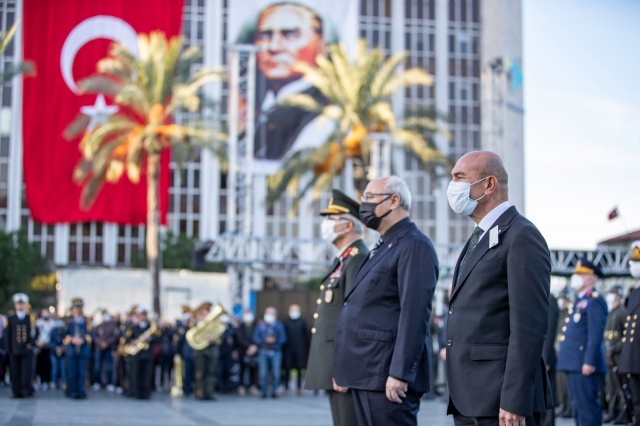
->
[267, 40, 449, 209]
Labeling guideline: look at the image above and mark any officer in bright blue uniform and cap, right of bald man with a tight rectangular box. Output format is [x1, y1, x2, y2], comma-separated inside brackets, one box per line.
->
[557, 258, 607, 426]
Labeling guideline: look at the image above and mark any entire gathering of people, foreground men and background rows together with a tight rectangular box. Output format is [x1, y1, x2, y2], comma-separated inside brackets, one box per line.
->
[0, 151, 640, 426]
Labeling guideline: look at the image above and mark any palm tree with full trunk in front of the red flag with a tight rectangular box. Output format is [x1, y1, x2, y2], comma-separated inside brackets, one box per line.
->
[65, 32, 224, 315]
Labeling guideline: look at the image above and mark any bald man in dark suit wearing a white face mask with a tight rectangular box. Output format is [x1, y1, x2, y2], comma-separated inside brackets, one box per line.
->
[446, 151, 552, 426]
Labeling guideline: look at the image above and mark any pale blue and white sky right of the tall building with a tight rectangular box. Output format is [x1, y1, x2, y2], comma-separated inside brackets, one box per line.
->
[523, 0, 640, 249]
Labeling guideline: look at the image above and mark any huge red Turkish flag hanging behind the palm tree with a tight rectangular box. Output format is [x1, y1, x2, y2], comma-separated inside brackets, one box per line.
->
[23, 0, 183, 225]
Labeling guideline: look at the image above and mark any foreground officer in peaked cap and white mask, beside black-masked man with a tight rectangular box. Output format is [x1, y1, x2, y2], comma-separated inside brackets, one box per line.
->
[304, 189, 369, 426]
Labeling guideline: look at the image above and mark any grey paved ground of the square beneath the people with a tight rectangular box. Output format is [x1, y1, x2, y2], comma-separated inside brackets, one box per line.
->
[0, 385, 572, 426]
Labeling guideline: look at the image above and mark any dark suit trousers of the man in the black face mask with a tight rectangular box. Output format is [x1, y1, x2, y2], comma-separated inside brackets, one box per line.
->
[352, 389, 422, 426]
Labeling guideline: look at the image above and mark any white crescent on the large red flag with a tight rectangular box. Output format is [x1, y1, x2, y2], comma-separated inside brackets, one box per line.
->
[60, 15, 138, 94]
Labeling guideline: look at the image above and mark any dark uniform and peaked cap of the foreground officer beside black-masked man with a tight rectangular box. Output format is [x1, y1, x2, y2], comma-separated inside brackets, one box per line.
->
[304, 190, 369, 426]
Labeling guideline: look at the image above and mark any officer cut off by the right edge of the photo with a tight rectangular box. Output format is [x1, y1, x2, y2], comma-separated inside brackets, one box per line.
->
[618, 241, 640, 425]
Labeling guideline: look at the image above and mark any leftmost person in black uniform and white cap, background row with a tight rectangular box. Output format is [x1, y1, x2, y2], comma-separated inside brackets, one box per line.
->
[4, 293, 34, 398]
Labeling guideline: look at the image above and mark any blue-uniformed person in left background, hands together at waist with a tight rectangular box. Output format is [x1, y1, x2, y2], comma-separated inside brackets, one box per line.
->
[62, 298, 92, 399]
